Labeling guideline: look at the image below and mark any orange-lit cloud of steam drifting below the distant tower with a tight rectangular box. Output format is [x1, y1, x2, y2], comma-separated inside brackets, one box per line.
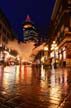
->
[6, 40, 45, 62]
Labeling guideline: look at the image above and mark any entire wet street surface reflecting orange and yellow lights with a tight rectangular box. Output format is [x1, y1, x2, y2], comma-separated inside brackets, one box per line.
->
[0, 65, 71, 108]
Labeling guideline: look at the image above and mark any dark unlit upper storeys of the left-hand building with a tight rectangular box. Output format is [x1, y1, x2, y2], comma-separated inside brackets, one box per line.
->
[0, 10, 15, 44]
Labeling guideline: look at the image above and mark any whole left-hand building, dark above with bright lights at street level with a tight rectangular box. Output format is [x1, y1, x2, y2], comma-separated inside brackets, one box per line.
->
[0, 9, 16, 63]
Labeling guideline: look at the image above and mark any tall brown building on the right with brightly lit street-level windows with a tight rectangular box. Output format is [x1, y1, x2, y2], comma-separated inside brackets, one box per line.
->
[49, 0, 71, 66]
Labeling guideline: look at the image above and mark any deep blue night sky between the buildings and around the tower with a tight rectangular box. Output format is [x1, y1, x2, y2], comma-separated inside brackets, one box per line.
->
[0, 0, 55, 40]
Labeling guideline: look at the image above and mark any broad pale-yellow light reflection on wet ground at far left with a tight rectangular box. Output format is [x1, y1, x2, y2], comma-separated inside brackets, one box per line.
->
[3, 66, 16, 91]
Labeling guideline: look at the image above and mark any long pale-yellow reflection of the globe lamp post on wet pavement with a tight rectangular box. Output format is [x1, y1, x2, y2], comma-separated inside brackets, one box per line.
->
[50, 68, 61, 104]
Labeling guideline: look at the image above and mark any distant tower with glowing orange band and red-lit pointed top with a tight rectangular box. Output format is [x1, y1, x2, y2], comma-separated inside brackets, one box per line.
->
[23, 15, 38, 43]
